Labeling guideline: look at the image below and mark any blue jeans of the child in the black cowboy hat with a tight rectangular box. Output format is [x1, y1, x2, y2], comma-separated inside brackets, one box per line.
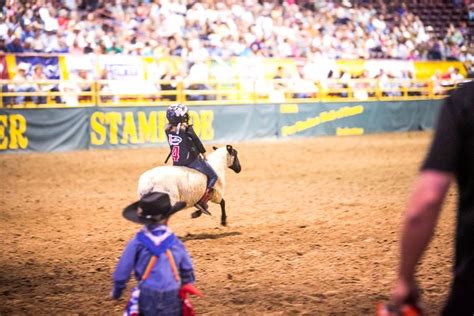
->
[138, 287, 182, 316]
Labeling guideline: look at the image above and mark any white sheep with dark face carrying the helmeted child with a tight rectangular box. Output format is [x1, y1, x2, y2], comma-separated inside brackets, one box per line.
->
[138, 145, 241, 226]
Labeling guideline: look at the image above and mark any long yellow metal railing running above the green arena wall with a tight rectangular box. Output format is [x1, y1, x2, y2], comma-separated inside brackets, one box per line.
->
[0, 79, 464, 108]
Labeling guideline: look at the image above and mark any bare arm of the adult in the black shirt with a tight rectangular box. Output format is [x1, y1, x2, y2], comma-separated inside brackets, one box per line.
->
[392, 170, 453, 306]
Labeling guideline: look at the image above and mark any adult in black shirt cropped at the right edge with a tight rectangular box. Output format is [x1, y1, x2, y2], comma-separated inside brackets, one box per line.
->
[391, 82, 474, 316]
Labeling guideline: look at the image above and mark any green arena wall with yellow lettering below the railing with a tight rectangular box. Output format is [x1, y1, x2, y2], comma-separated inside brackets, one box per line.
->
[0, 100, 442, 153]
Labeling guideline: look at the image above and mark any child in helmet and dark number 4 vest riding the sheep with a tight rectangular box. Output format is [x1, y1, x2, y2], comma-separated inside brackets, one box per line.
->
[165, 104, 217, 214]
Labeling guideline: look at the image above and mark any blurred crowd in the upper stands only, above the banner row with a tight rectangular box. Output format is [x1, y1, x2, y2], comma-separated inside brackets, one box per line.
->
[0, 0, 473, 63]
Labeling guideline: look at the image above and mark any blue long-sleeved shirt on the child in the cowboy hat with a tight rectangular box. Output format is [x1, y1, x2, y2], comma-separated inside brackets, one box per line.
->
[113, 225, 195, 292]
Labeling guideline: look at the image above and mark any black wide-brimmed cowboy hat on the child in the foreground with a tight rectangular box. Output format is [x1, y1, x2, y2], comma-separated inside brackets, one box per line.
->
[122, 192, 186, 224]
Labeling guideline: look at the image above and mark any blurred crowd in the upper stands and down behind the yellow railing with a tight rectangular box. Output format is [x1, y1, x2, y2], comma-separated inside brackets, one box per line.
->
[0, 0, 474, 104]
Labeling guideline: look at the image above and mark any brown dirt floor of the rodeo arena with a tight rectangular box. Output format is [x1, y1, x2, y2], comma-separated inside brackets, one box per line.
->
[0, 132, 456, 316]
